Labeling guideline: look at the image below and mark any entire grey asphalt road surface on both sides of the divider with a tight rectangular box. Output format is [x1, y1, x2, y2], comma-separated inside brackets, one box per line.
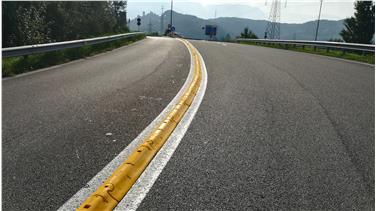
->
[3, 38, 375, 210]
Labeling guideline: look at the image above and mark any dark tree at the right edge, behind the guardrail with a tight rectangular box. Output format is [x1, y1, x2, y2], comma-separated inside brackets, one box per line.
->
[340, 1, 375, 44]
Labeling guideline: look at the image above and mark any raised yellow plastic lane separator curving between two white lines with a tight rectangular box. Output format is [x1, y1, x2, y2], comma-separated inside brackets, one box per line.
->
[77, 40, 202, 211]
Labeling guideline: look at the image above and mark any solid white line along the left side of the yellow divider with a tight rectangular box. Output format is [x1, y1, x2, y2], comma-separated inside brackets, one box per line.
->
[58, 38, 198, 210]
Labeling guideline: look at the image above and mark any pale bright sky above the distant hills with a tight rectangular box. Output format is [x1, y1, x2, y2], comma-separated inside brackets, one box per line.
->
[128, 0, 355, 23]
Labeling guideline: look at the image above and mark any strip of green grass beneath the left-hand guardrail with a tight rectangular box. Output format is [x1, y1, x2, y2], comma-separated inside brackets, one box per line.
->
[2, 35, 145, 77]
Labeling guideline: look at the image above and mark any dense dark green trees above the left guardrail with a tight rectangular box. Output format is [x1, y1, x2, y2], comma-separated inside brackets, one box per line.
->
[2, 1, 128, 47]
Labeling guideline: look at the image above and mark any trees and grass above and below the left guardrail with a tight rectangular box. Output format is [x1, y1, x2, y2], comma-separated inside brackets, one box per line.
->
[2, 1, 145, 77]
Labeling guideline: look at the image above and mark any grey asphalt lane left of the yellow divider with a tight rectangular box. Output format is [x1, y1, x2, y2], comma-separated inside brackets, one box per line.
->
[2, 38, 190, 210]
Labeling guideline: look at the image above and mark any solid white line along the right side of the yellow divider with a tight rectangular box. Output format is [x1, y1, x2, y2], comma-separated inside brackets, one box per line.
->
[115, 40, 207, 211]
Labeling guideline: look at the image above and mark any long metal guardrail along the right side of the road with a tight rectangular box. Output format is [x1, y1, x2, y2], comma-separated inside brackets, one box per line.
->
[236, 38, 375, 53]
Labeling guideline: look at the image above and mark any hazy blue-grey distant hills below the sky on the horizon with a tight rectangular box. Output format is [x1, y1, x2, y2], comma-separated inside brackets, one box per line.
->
[130, 11, 343, 40]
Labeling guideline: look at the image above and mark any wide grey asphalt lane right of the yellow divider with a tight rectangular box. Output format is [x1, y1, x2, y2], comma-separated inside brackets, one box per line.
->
[139, 41, 375, 210]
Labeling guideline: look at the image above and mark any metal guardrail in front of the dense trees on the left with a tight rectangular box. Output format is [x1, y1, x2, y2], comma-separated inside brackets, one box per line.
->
[2, 32, 145, 57]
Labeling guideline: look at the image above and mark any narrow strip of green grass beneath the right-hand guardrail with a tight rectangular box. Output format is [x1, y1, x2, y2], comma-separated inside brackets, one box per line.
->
[239, 42, 375, 64]
